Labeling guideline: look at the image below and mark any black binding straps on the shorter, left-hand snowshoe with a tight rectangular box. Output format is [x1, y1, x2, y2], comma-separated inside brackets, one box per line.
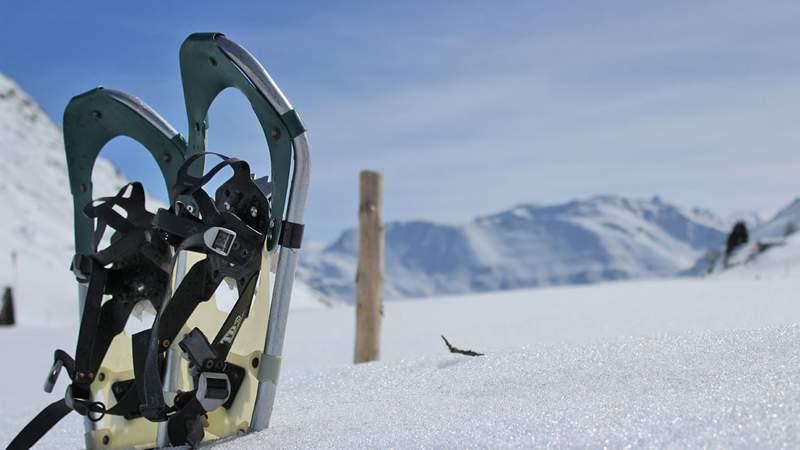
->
[9, 183, 169, 449]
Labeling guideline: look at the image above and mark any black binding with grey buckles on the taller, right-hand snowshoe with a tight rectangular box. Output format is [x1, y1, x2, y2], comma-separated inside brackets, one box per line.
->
[136, 153, 273, 445]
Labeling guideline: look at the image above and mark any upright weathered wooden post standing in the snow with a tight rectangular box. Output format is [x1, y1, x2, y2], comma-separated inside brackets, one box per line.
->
[354, 170, 384, 364]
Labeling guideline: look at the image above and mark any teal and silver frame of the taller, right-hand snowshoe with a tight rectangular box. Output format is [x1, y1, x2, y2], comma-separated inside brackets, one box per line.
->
[180, 33, 310, 431]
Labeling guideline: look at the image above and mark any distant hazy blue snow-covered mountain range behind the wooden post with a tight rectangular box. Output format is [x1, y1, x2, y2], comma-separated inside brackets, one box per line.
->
[299, 195, 726, 301]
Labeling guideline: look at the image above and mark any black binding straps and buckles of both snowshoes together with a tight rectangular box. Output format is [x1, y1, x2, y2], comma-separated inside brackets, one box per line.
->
[12, 153, 276, 450]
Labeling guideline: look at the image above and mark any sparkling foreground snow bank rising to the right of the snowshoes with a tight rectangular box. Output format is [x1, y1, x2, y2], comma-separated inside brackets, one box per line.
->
[219, 327, 800, 449]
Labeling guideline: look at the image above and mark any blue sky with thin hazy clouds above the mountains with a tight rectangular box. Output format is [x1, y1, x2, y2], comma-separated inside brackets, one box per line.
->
[0, 0, 800, 241]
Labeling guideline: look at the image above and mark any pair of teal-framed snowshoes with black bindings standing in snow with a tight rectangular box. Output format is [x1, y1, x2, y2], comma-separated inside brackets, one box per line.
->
[8, 33, 309, 449]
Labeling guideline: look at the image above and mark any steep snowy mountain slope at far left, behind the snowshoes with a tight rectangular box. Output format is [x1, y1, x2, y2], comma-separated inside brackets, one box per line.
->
[0, 74, 144, 322]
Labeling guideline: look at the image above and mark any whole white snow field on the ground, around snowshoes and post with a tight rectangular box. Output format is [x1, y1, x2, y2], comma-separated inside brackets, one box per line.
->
[0, 277, 800, 449]
